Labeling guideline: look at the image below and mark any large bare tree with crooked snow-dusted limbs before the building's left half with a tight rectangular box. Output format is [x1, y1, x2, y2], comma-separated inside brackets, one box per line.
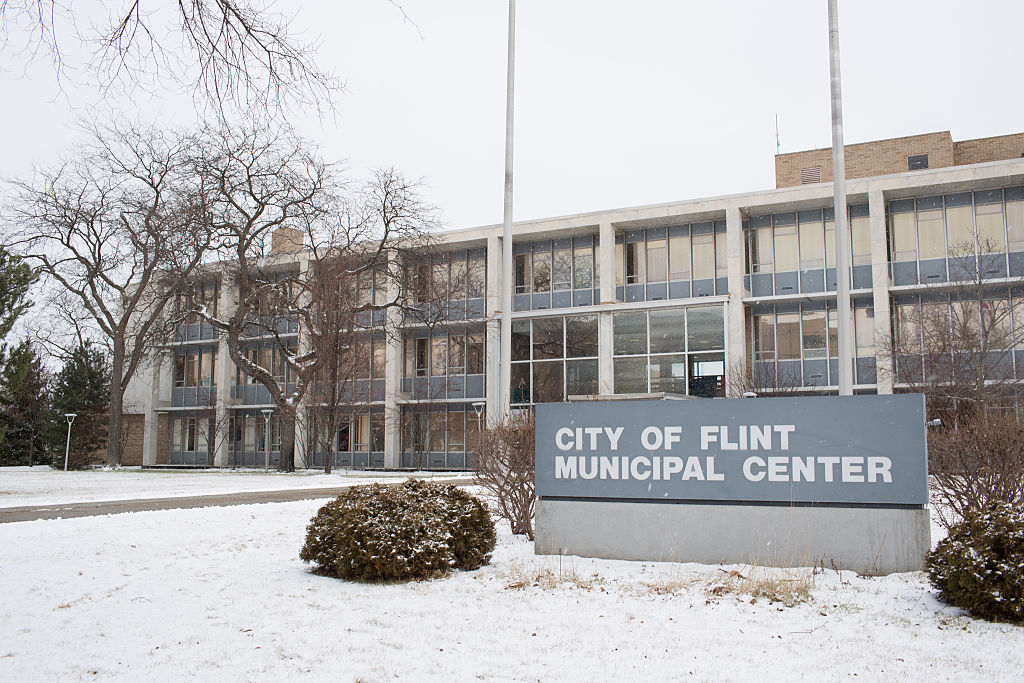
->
[196, 120, 433, 471]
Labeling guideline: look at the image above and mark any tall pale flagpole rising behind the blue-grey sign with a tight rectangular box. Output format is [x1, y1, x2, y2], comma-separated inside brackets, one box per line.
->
[828, 0, 853, 396]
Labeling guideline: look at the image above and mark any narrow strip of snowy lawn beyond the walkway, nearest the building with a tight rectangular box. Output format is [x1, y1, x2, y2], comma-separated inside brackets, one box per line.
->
[0, 466, 466, 508]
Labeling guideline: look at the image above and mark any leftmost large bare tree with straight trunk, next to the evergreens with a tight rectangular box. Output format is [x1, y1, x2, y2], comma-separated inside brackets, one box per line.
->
[7, 125, 211, 467]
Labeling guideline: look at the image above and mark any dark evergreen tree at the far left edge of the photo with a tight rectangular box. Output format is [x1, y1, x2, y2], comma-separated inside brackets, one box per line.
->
[0, 340, 59, 466]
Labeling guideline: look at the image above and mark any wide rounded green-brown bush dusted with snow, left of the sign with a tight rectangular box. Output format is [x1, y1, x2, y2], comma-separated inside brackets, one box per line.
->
[299, 479, 495, 581]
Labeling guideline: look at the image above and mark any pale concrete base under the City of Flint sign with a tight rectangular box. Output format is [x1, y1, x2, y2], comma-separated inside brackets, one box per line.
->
[535, 499, 931, 574]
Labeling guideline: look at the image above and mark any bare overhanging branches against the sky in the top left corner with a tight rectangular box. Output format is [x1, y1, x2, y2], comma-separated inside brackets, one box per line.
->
[0, 0, 341, 112]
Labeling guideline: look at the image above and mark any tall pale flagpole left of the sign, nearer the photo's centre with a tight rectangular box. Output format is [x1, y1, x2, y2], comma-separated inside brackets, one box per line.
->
[497, 0, 515, 420]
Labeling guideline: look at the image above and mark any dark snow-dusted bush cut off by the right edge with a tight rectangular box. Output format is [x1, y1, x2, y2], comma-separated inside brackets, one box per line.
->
[928, 503, 1024, 624]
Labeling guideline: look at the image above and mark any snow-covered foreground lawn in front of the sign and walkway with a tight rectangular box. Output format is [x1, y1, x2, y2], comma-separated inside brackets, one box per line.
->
[0, 499, 1024, 682]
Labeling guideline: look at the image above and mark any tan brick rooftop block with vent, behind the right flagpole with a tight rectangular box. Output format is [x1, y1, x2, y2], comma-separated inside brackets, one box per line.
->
[775, 130, 956, 187]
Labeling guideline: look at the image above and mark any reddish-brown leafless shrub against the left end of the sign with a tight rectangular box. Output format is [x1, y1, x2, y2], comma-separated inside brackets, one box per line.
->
[474, 414, 537, 541]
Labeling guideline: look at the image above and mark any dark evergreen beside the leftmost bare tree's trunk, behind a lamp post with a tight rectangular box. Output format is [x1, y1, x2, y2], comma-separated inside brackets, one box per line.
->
[53, 342, 111, 469]
